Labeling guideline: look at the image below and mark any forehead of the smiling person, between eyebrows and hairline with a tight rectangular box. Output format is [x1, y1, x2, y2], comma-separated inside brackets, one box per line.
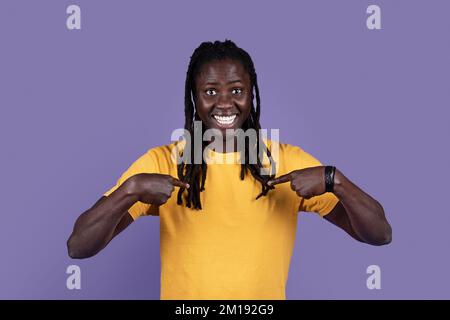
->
[196, 59, 250, 83]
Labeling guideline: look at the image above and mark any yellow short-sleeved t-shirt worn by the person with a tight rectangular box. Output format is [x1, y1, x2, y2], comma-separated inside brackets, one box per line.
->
[105, 143, 339, 299]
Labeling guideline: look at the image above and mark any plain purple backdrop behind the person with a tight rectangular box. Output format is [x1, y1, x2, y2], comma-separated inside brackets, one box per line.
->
[0, 0, 450, 299]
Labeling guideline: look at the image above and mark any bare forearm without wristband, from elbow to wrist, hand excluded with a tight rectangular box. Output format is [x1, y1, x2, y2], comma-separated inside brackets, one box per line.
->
[67, 179, 137, 259]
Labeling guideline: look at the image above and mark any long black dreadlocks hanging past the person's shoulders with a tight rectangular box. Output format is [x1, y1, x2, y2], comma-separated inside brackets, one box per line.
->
[177, 40, 275, 209]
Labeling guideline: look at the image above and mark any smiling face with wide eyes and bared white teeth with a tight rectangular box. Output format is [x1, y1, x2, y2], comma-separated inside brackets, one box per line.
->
[195, 59, 252, 137]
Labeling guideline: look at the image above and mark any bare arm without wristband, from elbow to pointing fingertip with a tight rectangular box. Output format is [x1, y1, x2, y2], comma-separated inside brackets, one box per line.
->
[67, 173, 189, 259]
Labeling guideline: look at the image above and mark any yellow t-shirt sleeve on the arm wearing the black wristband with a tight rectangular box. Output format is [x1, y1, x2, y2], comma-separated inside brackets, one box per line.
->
[286, 147, 339, 217]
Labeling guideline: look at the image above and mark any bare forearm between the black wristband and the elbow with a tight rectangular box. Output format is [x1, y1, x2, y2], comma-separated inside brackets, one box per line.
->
[334, 169, 392, 245]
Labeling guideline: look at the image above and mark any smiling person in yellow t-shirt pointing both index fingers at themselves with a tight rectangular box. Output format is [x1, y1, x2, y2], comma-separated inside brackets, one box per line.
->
[67, 40, 392, 299]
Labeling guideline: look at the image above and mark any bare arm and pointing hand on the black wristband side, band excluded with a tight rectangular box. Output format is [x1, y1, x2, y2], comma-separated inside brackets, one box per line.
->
[268, 166, 392, 245]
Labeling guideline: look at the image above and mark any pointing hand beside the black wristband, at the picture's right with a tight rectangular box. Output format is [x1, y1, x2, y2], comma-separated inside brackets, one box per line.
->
[267, 166, 325, 199]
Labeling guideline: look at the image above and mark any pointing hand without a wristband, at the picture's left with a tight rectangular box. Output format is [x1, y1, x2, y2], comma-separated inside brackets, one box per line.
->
[131, 173, 189, 206]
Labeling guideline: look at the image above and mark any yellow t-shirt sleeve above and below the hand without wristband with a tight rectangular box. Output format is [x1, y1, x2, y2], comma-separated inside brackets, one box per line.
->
[103, 151, 159, 220]
